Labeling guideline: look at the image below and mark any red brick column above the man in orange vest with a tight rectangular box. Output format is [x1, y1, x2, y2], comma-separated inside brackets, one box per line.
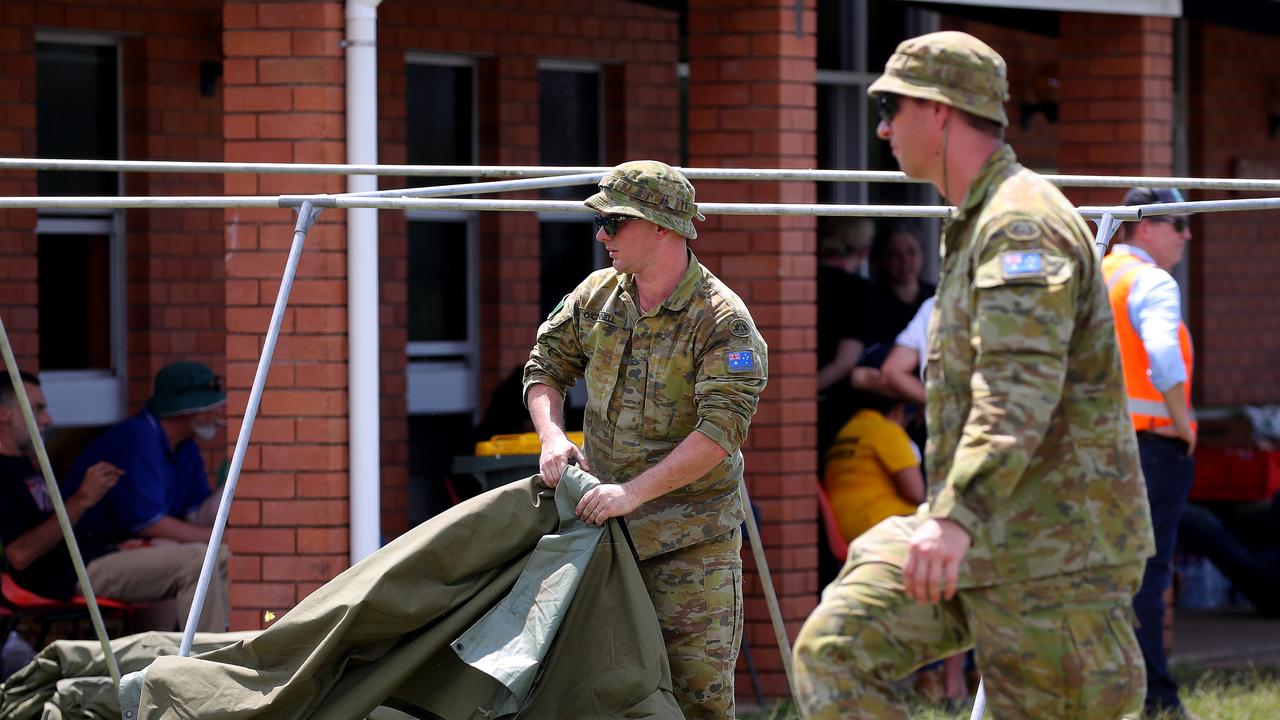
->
[1059, 13, 1174, 204]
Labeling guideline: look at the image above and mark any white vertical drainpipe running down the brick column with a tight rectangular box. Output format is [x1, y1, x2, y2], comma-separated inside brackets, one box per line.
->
[344, 0, 381, 564]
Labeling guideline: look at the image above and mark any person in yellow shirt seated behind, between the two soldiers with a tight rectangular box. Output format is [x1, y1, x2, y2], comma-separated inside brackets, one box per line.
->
[822, 393, 924, 541]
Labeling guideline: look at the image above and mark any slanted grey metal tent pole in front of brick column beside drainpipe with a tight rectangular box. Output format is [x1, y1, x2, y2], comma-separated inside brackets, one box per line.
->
[177, 202, 320, 655]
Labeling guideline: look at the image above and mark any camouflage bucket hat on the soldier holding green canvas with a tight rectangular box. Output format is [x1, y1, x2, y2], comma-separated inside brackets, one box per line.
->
[584, 160, 707, 240]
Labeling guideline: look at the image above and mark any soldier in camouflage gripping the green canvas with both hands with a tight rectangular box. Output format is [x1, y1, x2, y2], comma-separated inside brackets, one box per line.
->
[525, 160, 767, 719]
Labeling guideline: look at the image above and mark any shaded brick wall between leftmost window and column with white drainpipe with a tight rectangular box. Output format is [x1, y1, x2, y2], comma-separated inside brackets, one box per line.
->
[120, 12, 227, 477]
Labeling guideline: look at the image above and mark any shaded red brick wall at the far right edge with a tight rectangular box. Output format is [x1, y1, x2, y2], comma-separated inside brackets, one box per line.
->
[1188, 23, 1280, 405]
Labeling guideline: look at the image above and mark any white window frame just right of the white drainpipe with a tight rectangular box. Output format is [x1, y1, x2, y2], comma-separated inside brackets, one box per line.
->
[404, 51, 481, 420]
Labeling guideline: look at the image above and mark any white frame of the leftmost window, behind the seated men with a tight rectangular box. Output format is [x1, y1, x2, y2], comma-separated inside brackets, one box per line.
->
[36, 31, 129, 427]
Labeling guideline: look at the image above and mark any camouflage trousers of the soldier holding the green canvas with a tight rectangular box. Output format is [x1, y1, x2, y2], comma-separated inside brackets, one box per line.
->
[640, 529, 742, 720]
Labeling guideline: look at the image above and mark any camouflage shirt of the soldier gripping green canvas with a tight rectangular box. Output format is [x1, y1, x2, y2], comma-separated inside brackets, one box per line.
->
[524, 252, 768, 560]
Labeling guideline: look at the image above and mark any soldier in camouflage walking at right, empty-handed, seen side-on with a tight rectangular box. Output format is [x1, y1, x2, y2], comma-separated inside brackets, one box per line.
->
[795, 32, 1153, 720]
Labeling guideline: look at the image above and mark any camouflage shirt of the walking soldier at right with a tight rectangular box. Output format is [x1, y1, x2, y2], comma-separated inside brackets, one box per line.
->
[920, 146, 1155, 587]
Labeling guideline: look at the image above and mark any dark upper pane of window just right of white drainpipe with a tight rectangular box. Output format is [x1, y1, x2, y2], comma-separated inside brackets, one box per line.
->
[404, 63, 474, 187]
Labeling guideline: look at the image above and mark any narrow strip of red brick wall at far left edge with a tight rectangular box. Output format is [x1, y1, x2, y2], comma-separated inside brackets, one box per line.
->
[0, 9, 40, 368]
